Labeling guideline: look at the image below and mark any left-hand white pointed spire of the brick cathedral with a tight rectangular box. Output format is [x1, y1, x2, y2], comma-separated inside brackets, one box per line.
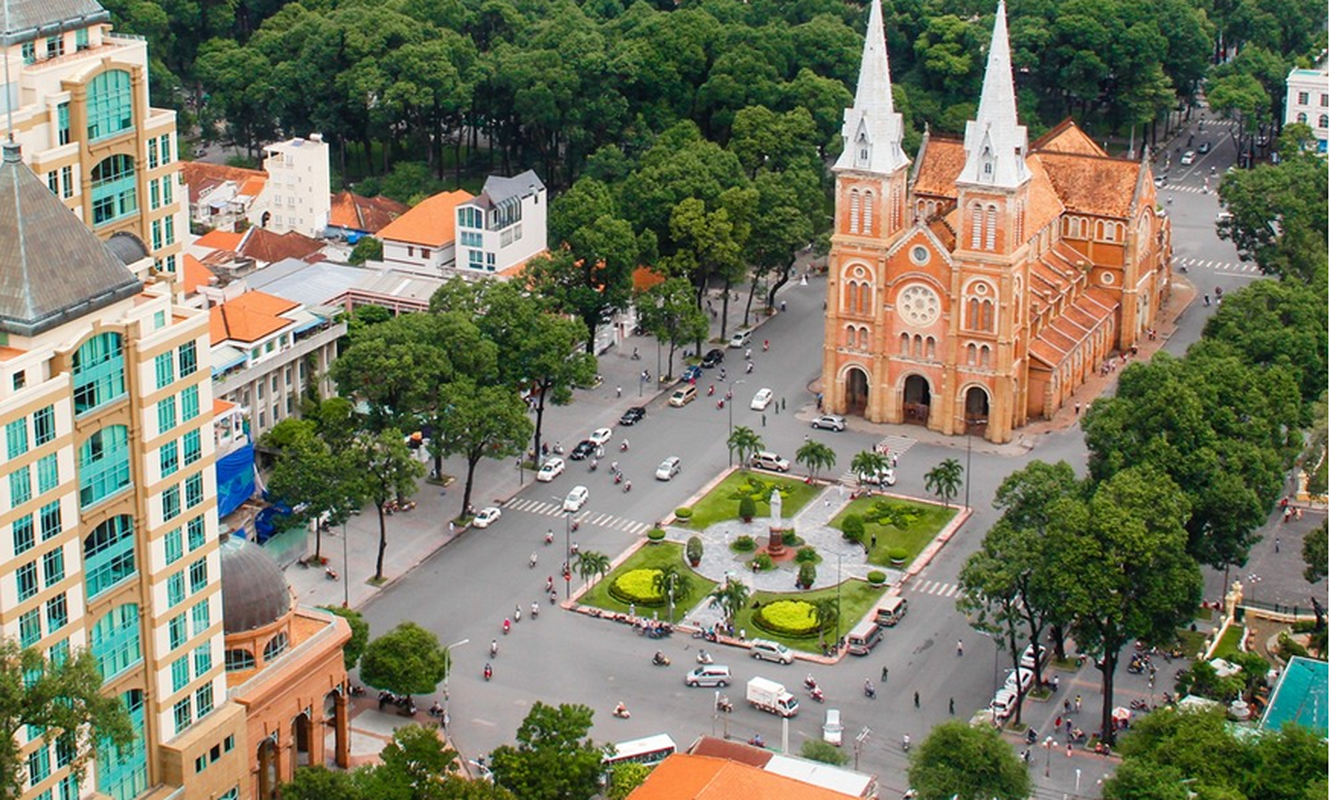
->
[835, 0, 910, 174]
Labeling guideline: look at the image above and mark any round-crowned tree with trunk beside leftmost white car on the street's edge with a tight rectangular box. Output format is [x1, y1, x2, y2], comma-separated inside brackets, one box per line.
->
[435, 379, 533, 513]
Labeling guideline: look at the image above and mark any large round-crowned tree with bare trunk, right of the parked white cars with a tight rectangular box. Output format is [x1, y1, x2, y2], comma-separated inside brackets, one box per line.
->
[1048, 466, 1201, 743]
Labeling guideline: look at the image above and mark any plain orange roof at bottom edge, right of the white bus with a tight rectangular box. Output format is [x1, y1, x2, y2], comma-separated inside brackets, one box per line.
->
[628, 753, 854, 800]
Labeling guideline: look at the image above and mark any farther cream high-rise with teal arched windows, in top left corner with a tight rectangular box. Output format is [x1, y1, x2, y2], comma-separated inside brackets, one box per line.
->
[0, 0, 189, 274]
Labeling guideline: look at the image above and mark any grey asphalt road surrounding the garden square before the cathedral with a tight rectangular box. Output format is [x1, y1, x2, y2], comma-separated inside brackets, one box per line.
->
[364, 108, 1319, 797]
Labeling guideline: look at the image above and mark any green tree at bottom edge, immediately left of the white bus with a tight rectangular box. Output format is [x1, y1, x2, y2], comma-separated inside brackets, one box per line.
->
[491, 700, 606, 800]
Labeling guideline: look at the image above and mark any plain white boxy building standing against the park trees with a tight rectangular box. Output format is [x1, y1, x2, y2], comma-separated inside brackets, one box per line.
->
[247, 133, 333, 239]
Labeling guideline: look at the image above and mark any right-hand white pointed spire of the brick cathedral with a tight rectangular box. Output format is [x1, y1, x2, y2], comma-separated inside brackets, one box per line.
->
[958, 0, 1029, 189]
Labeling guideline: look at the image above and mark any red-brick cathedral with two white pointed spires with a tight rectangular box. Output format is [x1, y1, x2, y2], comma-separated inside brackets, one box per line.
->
[822, 0, 1172, 443]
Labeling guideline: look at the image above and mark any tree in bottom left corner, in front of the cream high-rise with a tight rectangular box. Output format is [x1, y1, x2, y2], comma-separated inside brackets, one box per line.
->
[0, 639, 133, 797]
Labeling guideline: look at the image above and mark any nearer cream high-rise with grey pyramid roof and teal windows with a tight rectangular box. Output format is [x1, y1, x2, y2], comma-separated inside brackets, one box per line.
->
[0, 143, 249, 800]
